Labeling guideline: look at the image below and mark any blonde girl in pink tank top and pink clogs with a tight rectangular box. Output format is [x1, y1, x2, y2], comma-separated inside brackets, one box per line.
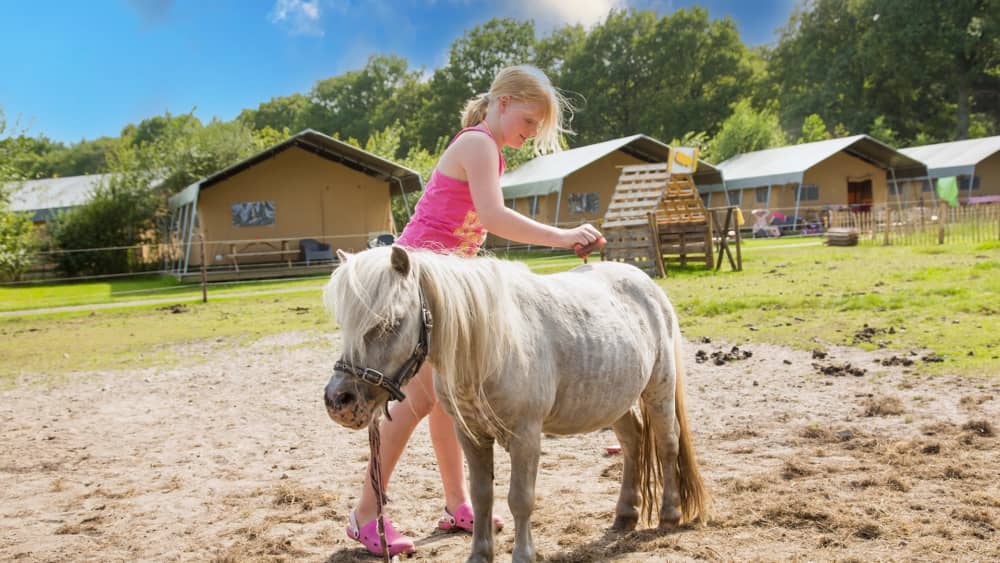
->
[347, 66, 601, 555]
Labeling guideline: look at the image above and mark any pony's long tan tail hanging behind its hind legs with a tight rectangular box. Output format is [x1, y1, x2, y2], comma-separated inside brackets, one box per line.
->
[672, 315, 711, 524]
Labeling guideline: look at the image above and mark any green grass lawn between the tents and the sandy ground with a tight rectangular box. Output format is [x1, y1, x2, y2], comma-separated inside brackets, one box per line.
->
[0, 238, 1000, 383]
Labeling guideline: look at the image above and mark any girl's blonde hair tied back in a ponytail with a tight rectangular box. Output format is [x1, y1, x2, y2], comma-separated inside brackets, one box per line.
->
[462, 65, 573, 154]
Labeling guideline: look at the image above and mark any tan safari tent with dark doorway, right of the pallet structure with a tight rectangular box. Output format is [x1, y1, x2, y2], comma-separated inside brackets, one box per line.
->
[716, 135, 927, 227]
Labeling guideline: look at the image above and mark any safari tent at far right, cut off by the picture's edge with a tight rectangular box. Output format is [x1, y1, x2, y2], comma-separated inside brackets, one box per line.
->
[899, 136, 1000, 203]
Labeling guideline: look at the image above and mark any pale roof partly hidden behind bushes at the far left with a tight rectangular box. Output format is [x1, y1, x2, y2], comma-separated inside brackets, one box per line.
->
[10, 174, 110, 222]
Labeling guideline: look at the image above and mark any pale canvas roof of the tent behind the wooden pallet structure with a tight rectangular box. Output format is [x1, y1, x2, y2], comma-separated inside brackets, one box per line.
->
[500, 134, 722, 199]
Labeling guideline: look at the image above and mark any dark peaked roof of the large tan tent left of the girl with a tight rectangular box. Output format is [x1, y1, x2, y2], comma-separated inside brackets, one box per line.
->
[170, 129, 423, 209]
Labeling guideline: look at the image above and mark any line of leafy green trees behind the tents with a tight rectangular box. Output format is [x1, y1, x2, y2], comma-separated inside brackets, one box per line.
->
[0, 0, 1000, 278]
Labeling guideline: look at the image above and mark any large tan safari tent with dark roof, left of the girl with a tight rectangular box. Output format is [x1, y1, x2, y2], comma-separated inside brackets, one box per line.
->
[170, 129, 422, 275]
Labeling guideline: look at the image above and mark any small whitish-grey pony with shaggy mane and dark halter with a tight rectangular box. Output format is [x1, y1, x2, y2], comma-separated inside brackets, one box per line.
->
[324, 246, 708, 561]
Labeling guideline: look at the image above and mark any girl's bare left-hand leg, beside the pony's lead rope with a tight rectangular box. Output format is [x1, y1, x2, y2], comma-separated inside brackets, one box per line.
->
[354, 362, 442, 525]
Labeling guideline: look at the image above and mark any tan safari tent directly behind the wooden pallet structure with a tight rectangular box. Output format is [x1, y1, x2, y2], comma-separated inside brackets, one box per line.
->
[496, 134, 722, 244]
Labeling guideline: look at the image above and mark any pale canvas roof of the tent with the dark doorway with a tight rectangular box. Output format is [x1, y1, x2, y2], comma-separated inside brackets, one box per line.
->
[718, 135, 927, 190]
